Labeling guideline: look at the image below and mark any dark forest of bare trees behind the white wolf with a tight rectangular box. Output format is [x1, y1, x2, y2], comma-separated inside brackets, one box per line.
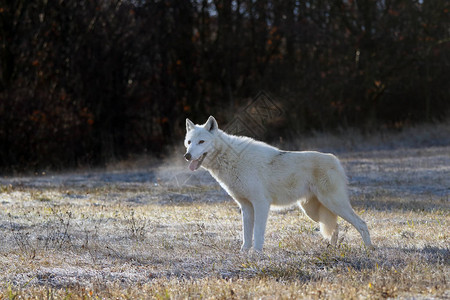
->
[0, 0, 450, 172]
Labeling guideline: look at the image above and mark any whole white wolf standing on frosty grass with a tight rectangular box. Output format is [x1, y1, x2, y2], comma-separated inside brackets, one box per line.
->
[184, 116, 372, 251]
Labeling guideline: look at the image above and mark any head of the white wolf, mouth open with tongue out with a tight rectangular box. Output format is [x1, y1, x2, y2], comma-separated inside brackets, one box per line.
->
[184, 116, 219, 171]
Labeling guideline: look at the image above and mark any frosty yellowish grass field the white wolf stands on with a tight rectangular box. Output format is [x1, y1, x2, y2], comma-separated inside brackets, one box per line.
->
[0, 127, 450, 299]
